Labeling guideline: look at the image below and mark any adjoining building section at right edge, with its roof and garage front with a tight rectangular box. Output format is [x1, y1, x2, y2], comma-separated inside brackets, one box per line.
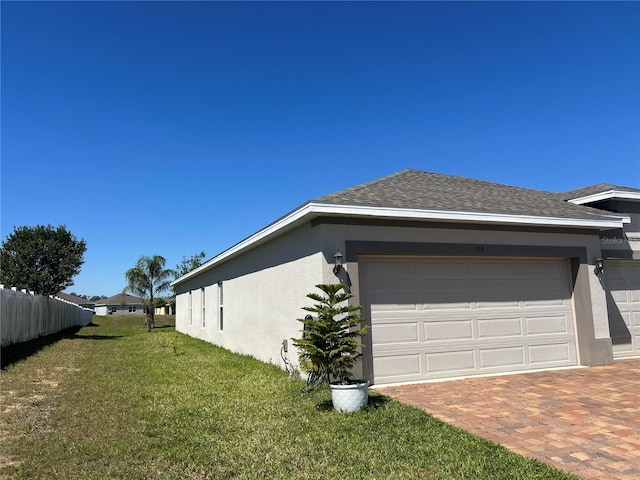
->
[563, 184, 640, 358]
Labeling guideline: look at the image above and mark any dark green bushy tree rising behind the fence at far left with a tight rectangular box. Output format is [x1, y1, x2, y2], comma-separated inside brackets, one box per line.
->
[0, 225, 87, 295]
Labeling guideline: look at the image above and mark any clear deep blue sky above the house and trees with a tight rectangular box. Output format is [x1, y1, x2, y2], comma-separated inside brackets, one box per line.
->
[0, 1, 640, 296]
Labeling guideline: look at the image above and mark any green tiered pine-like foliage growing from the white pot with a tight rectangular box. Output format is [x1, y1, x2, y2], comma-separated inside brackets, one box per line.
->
[292, 283, 369, 390]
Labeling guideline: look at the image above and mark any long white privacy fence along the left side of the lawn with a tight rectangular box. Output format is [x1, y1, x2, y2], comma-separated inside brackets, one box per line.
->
[0, 285, 93, 347]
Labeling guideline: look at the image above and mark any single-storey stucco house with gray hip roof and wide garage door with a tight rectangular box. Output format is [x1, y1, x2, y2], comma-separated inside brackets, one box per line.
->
[173, 170, 640, 384]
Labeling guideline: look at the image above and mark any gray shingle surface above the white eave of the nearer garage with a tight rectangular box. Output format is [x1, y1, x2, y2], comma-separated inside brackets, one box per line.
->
[310, 169, 608, 220]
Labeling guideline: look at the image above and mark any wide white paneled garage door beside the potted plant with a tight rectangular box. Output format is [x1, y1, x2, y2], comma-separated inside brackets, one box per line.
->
[359, 257, 577, 384]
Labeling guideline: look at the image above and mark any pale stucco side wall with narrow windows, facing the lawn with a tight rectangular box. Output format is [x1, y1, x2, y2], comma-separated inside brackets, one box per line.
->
[176, 225, 323, 366]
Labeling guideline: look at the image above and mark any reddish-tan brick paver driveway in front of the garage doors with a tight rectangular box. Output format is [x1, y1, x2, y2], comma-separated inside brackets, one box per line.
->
[379, 359, 640, 480]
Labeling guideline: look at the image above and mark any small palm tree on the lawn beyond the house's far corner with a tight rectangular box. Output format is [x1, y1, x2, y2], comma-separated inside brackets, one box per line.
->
[124, 255, 175, 330]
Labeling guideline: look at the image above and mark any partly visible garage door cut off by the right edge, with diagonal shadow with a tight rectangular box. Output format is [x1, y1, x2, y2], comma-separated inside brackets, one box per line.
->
[603, 260, 640, 358]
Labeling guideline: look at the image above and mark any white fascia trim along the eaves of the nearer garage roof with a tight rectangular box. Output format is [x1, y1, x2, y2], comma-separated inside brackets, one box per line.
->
[172, 203, 630, 285]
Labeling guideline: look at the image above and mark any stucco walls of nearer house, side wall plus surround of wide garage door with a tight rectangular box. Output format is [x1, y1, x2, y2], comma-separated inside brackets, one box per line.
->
[176, 221, 611, 374]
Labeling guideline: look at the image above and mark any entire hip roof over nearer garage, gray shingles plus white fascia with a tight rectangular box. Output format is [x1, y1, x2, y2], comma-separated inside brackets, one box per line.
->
[172, 169, 622, 285]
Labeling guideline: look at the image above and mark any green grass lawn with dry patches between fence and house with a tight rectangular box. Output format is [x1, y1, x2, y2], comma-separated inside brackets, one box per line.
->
[0, 316, 575, 480]
